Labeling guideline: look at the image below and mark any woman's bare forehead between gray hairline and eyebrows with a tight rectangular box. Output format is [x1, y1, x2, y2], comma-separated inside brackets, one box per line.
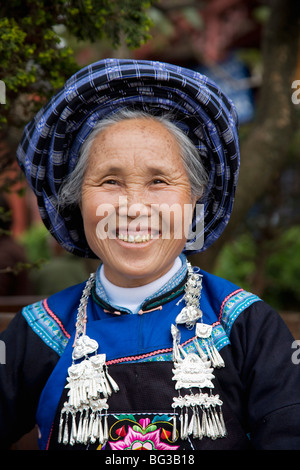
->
[86, 118, 186, 181]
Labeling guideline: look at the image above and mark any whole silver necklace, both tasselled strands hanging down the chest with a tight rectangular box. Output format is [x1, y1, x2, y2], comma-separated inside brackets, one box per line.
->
[58, 262, 226, 446]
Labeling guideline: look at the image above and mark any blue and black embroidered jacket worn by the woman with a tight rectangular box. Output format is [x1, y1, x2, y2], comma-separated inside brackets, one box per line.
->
[0, 271, 300, 449]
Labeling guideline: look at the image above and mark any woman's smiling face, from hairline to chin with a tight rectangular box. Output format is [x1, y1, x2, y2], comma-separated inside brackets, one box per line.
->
[81, 119, 196, 287]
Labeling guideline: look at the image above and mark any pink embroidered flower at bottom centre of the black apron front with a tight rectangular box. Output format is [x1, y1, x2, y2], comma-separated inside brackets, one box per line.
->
[109, 422, 179, 450]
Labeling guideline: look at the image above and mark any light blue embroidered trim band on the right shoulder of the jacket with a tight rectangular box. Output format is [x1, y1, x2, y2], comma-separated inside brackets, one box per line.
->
[219, 289, 261, 336]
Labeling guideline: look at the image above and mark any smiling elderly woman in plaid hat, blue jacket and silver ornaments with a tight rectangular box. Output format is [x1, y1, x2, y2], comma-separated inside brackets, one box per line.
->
[0, 59, 300, 450]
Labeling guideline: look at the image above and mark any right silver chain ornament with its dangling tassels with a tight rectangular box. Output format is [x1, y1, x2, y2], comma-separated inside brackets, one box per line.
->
[171, 263, 226, 441]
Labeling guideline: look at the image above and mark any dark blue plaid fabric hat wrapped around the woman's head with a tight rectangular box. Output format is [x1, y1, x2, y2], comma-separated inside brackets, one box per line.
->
[17, 59, 239, 258]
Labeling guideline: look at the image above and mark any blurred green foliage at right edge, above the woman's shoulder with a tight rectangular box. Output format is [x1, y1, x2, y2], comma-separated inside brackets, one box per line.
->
[215, 225, 300, 311]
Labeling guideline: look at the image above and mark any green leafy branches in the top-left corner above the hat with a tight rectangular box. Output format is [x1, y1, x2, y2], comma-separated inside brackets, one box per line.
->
[0, 0, 152, 126]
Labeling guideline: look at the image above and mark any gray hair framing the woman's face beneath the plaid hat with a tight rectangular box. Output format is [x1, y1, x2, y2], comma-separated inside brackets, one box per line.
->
[58, 109, 208, 208]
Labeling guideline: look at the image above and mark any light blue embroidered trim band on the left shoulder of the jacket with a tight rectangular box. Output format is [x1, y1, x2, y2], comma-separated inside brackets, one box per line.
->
[22, 300, 70, 356]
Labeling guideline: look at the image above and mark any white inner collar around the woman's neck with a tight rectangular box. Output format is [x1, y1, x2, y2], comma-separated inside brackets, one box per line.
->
[100, 257, 182, 313]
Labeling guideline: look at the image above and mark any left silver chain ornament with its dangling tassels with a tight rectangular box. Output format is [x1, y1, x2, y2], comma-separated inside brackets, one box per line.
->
[58, 274, 119, 446]
